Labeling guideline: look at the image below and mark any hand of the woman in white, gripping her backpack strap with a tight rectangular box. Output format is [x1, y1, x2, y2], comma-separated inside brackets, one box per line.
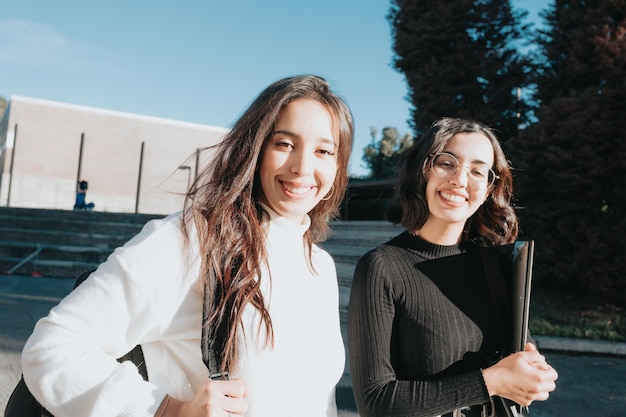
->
[156, 379, 248, 417]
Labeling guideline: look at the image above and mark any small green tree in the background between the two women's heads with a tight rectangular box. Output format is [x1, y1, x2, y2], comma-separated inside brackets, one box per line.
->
[363, 127, 413, 180]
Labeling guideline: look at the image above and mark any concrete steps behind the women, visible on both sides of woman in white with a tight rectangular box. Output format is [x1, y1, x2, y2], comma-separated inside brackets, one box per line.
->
[0, 207, 401, 320]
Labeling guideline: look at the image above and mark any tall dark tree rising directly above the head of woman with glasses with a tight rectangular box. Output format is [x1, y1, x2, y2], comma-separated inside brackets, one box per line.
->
[387, 0, 531, 140]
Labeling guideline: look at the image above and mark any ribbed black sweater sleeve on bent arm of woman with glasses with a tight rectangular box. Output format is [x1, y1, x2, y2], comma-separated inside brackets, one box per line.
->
[348, 252, 489, 417]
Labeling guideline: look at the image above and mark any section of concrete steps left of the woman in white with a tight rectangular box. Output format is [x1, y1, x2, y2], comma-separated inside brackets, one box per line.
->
[0, 207, 162, 278]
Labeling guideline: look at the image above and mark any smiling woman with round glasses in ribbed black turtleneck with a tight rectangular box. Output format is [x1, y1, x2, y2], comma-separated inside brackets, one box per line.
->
[348, 118, 557, 417]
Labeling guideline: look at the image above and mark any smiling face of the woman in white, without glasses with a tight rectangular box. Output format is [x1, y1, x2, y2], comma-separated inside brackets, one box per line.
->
[259, 99, 337, 223]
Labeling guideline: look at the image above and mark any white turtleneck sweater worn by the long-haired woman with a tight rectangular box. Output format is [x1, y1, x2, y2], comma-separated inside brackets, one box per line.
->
[22, 213, 345, 417]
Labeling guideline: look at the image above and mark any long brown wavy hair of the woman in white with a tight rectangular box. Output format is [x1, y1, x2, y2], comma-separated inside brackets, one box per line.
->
[183, 75, 354, 370]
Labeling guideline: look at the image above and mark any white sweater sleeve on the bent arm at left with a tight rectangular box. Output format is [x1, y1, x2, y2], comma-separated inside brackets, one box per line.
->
[22, 214, 190, 417]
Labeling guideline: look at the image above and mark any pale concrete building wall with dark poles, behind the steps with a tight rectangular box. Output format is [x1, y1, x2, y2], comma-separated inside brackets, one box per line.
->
[0, 96, 227, 214]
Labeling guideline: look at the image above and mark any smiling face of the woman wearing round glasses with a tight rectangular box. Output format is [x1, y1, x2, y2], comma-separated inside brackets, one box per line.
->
[422, 133, 494, 243]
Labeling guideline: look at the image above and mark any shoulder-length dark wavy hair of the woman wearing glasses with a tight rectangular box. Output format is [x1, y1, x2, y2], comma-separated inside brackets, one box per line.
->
[386, 118, 519, 246]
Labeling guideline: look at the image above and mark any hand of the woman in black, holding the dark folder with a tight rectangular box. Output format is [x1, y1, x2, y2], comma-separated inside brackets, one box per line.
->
[483, 343, 558, 406]
